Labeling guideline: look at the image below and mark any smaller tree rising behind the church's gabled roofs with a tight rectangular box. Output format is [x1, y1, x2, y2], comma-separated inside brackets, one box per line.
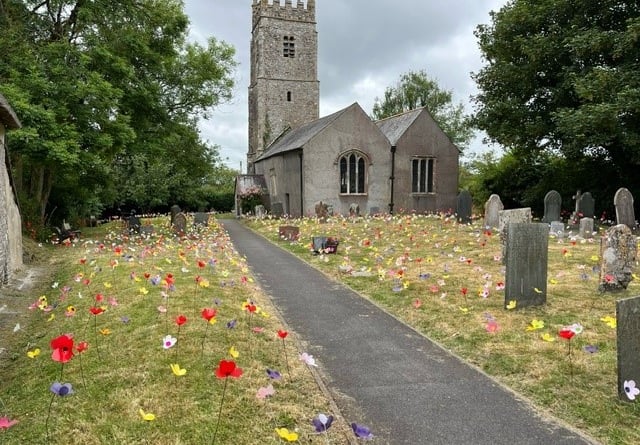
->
[372, 71, 473, 150]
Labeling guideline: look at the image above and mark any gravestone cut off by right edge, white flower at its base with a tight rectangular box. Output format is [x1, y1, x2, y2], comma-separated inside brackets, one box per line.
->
[616, 297, 640, 402]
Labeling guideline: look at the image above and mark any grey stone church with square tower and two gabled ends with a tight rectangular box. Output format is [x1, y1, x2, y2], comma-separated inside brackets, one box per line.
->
[236, 0, 460, 217]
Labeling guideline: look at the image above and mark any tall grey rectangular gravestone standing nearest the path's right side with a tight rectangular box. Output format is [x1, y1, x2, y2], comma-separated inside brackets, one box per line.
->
[504, 223, 549, 308]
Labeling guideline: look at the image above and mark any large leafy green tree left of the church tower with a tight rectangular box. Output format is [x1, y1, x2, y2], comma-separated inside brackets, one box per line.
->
[0, 0, 235, 222]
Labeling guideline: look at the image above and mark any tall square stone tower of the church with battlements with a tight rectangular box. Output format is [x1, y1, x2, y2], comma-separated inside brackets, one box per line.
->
[247, 0, 320, 174]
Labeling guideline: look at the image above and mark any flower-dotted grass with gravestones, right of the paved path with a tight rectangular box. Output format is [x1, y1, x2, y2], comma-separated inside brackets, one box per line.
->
[248, 215, 640, 444]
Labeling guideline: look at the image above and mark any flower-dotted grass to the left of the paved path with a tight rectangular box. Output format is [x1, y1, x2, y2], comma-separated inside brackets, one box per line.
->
[0, 219, 352, 445]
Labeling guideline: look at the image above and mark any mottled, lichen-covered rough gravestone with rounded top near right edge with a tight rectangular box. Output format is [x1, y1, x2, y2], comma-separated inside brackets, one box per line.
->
[598, 224, 637, 292]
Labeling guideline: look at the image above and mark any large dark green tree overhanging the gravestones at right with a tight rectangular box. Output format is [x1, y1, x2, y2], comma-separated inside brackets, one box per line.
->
[472, 0, 640, 200]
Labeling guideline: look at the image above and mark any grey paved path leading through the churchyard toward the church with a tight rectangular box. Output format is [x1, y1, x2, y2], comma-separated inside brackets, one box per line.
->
[221, 220, 596, 445]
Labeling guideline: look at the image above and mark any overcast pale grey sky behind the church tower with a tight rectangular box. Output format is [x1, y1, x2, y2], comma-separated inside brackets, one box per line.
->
[185, 0, 507, 172]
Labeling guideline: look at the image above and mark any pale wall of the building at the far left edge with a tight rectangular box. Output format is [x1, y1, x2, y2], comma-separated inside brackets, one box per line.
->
[0, 94, 23, 287]
